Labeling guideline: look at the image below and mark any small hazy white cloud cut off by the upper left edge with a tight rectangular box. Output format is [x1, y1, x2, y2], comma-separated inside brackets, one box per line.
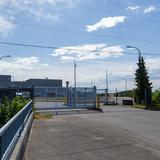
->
[0, 16, 15, 37]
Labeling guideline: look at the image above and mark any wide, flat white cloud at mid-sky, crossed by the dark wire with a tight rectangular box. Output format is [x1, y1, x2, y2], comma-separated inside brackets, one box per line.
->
[51, 44, 124, 61]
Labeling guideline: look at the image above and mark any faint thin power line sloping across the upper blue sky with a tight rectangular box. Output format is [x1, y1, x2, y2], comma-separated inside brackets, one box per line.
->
[4, 19, 160, 44]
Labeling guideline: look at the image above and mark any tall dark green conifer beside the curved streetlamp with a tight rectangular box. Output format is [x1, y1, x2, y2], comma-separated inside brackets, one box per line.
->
[135, 57, 152, 104]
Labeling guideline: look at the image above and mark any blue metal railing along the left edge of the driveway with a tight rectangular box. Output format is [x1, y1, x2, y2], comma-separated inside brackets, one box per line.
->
[0, 101, 32, 160]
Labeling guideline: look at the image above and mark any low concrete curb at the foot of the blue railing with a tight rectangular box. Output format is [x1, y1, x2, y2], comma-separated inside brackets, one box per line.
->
[10, 112, 34, 160]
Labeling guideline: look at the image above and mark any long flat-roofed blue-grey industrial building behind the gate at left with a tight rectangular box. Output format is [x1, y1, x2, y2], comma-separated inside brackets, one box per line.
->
[0, 75, 62, 99]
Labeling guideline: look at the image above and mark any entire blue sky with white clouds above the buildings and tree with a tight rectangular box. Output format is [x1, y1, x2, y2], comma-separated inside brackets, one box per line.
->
[0, 0, 160, 91]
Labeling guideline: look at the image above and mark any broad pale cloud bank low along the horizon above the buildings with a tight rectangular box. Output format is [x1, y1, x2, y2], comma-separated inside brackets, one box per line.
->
[1, 55, 160, 91]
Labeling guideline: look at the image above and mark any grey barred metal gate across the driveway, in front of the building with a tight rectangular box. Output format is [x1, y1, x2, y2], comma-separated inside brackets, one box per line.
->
[34, 86, 96, 108]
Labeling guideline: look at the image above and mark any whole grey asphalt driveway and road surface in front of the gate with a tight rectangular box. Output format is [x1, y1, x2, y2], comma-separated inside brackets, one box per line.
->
[25, 106, 160, 160]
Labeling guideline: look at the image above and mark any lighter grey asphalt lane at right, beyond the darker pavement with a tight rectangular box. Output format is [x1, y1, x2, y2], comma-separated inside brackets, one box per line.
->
[89, 106, 160, 143]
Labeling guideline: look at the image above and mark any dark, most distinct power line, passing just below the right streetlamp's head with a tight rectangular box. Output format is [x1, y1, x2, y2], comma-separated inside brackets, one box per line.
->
[0, 41, 160, 56]
